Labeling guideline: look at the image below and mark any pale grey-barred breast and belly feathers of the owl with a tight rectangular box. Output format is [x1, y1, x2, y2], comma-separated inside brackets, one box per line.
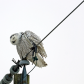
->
[16, 36, 32, 59]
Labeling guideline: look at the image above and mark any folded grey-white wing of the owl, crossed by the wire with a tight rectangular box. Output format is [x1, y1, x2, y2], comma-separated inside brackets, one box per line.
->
[24, 31, 47, 57]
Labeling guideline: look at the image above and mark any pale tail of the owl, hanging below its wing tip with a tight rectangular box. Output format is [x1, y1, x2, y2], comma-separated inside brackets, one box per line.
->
[29, 54, 47, 68]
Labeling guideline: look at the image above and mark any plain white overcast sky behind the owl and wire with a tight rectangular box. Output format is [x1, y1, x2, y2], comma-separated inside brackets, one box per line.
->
[0, 0, 84, 84]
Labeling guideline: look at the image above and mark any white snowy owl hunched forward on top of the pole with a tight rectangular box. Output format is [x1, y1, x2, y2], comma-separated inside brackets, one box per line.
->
[10, 31, 47, 67]
